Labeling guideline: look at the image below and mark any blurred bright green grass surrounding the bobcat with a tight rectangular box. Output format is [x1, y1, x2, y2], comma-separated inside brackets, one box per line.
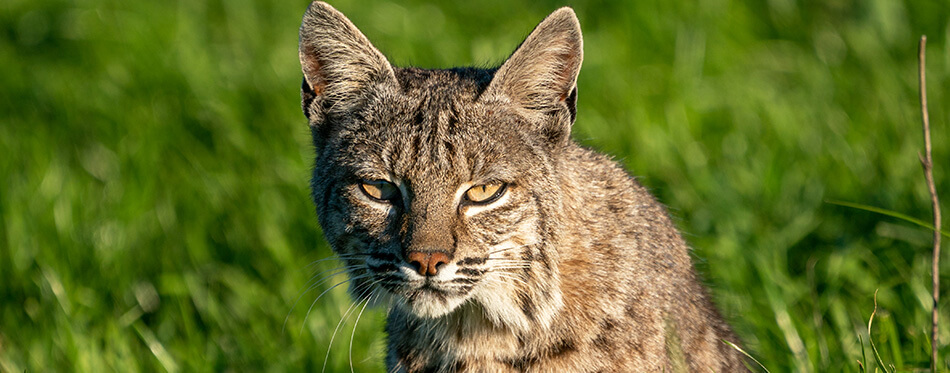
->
[0, 0, 950, 372]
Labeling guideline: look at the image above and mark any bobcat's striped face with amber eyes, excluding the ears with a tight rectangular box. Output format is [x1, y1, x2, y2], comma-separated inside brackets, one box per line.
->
[314, 72, 549, 317]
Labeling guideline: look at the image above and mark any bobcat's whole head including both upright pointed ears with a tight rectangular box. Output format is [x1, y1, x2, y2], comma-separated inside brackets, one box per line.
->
[300, 2, 582, 326]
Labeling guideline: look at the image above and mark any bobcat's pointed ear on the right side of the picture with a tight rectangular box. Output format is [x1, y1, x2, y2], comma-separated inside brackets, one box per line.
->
[482, 7, 584, 137]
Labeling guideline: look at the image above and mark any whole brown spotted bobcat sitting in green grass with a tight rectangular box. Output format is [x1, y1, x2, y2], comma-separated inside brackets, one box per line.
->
[300, 1, 746, 372]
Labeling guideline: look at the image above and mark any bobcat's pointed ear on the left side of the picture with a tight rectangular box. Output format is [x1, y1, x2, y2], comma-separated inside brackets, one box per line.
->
[299, 1, 396, 127]
